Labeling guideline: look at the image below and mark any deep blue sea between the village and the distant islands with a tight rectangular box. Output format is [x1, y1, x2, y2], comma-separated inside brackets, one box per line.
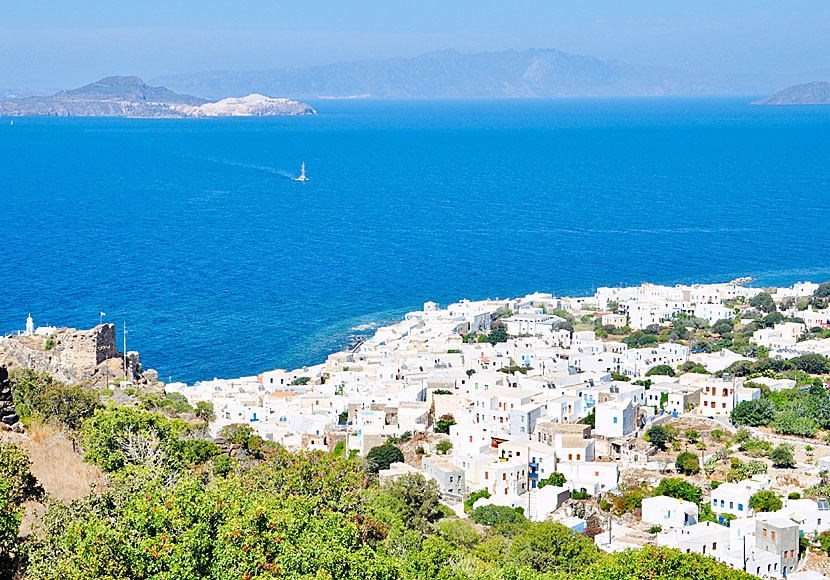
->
[0, 97, 830, 382]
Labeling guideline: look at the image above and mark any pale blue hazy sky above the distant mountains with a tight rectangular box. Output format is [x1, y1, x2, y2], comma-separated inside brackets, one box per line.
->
[0, 0, 830, 89]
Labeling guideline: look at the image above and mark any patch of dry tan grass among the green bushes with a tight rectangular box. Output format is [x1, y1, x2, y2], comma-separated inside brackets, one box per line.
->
[21, 423, 106, 501]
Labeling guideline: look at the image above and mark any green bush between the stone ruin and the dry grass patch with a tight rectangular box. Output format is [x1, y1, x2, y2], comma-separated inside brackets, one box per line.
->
[9, 369, 102, 430]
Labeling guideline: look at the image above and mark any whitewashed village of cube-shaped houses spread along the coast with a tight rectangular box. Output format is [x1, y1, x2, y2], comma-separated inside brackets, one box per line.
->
[154, 279, 830, 580]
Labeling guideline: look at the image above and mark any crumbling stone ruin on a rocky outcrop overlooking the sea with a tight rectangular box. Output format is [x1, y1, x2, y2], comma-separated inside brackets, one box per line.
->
[0, 324, 158, 386]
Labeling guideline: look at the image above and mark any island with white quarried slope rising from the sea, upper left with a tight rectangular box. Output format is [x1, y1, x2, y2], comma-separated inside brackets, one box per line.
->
[0, 76, 316, 119]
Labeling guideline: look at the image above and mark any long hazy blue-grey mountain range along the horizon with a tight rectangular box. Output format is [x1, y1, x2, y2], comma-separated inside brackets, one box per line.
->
[154, 49, 722, 99]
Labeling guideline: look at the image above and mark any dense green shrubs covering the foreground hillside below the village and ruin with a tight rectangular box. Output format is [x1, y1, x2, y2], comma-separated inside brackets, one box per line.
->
[0, 373, 760, 580]
